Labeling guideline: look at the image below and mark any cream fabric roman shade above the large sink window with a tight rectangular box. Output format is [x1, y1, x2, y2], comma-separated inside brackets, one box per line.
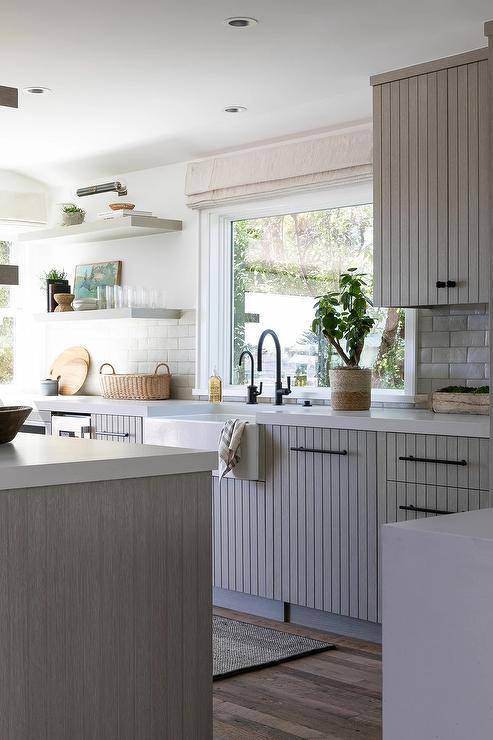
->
[185, 126, 372, 208]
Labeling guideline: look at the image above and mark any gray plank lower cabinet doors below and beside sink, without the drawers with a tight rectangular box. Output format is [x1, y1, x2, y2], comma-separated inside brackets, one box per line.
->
[213, 426, 378, 621]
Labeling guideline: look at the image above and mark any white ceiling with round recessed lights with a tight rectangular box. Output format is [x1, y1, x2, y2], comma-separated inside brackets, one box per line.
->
[0, 0, 493, 183]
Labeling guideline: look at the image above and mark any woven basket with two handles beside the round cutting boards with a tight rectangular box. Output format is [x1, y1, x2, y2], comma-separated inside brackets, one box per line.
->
[99, 362, 171, 401]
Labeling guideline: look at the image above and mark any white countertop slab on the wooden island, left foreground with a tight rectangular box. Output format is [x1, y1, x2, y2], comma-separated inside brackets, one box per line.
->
[0, 434, 217, 490]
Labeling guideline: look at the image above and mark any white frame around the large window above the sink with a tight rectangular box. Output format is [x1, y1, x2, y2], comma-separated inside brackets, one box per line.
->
[193, 185, 416, 403]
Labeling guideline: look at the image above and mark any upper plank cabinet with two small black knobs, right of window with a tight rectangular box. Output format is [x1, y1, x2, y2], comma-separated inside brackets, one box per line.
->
[371, 48, 489, 307]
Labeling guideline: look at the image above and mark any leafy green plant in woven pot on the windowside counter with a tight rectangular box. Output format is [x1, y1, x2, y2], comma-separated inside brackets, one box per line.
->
[312, 267, 375, 411]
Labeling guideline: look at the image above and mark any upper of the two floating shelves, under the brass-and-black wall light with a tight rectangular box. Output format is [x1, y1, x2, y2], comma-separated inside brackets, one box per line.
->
[18, 216, 182, 242]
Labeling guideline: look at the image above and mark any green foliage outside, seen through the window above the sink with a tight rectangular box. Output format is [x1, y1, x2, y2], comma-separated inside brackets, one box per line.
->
[232, 204, 404, 389]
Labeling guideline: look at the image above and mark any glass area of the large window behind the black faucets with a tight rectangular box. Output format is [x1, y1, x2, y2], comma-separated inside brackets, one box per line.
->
[230, 204, 406, 390]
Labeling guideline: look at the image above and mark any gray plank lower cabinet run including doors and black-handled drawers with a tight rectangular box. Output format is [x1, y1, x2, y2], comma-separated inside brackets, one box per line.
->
[213, 425, 491, 622]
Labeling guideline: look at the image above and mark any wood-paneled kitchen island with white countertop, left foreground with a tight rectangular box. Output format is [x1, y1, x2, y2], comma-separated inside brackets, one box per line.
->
[0, 434, 216, 740]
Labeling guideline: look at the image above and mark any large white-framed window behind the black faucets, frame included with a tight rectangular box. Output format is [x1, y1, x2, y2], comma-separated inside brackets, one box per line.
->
[198, 184, 415, 401]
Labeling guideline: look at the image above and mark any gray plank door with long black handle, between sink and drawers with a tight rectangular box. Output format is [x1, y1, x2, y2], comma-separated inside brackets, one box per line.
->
[282, 427, 378, 621]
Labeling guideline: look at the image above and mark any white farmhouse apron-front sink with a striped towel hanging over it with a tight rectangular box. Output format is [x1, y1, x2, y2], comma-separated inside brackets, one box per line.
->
[144, 412, 260, 480]
